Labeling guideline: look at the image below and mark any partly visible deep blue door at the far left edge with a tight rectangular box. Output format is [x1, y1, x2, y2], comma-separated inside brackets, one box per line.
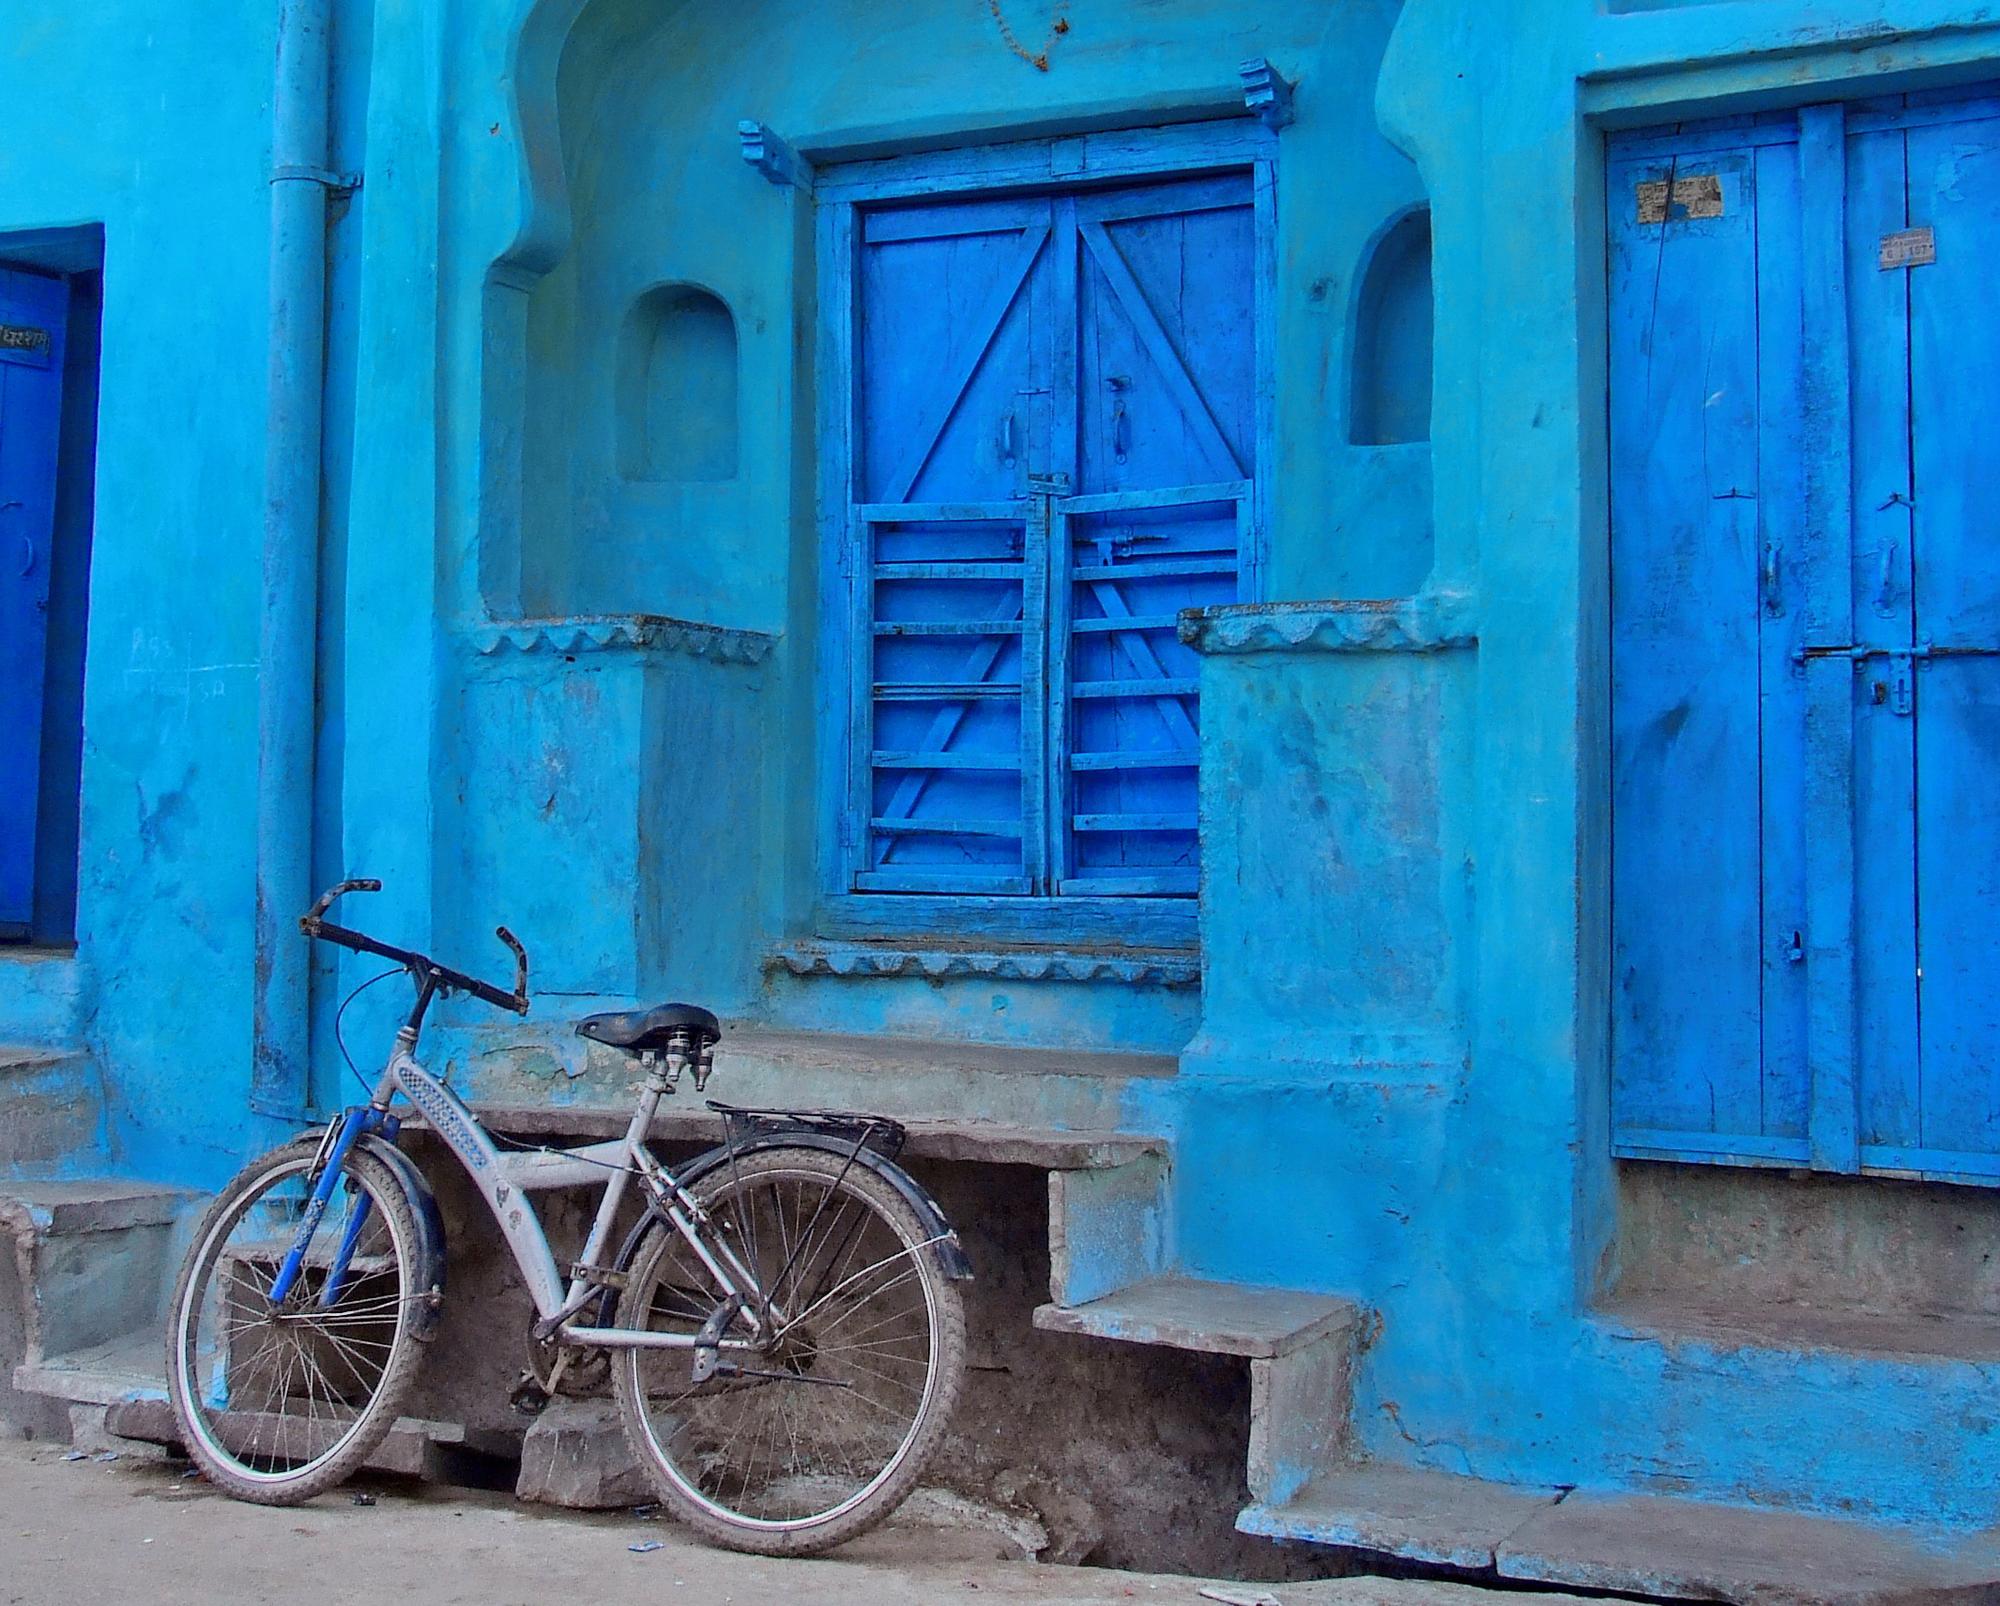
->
[0, 268, 68, 938]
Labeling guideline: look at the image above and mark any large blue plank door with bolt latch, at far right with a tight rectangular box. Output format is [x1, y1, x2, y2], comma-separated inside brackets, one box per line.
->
[1608, 92, 2000, 1182]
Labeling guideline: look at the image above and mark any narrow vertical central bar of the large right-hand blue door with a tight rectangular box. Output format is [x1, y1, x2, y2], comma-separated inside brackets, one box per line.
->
[1798, 104, 1860, 1172]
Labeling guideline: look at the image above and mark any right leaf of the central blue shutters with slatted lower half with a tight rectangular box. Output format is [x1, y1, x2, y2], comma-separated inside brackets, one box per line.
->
[1052, 185, 1256, 894]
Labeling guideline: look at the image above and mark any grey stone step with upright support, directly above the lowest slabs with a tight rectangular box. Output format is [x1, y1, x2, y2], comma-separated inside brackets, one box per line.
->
[1034, 1276, 1360, 1502]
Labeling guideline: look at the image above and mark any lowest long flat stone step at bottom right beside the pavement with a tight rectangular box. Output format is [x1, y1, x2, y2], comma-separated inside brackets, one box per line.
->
[1236, 1464, 2000, 1606]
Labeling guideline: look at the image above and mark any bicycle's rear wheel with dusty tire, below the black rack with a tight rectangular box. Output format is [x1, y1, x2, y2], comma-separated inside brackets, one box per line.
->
[612, 1148, 966, 1556]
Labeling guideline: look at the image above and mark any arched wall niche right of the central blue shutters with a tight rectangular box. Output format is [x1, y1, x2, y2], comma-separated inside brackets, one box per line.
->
[1348, 210, 1432, 446]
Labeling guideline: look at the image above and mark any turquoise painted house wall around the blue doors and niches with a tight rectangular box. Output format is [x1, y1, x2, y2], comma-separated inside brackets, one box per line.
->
[0, 0, 2000, 1524]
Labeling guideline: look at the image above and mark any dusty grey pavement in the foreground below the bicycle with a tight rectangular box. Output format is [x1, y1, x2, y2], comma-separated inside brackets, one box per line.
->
[0, 1442, 1582, 1606]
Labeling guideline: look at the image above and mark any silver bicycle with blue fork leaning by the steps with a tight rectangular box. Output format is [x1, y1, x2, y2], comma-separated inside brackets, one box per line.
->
[168, 880, 972, 1556]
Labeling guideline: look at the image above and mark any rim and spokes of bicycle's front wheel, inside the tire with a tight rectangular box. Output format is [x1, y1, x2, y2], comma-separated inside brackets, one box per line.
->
[174, 1156, 410, 1484]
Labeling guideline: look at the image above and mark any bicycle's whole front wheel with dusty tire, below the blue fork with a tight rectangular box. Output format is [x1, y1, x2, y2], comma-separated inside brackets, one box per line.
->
[166, 1142, 428, 1506]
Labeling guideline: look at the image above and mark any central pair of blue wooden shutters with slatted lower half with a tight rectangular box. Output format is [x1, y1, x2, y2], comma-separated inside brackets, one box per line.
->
[844, 176, 1258, 896]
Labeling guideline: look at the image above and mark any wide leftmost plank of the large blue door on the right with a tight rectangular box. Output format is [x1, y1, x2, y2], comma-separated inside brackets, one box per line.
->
[1610, 148, 1802, 1150]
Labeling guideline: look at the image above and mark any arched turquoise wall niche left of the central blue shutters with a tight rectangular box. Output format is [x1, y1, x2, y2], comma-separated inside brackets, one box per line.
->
[618, 284, 736, 484]
